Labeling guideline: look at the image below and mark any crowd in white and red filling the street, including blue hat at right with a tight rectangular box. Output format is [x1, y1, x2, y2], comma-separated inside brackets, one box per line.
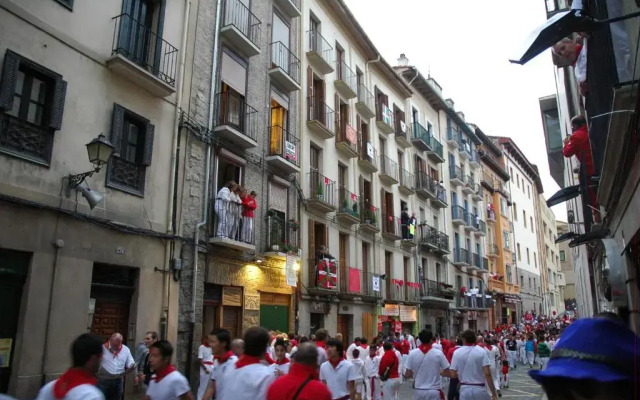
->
[30, 313, 640, 400]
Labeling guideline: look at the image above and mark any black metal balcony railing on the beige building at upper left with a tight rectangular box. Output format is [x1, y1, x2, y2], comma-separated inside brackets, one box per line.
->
[111, 14, 178, 86]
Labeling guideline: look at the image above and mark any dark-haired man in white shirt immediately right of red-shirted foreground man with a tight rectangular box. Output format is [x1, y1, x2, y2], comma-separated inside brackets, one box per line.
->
[320, 339, 356, 400]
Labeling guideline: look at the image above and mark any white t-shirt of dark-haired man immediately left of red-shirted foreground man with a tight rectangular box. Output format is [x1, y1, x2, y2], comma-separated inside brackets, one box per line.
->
[217, 361, 276, 400]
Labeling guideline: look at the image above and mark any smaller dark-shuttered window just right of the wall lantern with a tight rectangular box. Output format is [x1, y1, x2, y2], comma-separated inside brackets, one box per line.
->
[107, 104, 154, 196]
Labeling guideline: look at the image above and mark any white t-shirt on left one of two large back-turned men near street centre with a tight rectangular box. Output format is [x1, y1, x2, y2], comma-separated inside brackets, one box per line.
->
[405, 347, 449, 390]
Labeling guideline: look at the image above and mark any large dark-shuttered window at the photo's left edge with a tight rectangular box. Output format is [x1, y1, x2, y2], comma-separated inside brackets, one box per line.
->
[0, 50, 67, 166]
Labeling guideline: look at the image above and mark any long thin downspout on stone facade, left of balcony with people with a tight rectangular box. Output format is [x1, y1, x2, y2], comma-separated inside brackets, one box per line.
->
[191, 0, 222, 324]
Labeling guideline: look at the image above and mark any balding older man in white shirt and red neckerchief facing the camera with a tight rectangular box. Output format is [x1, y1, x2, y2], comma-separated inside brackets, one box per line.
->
[96, 333, 136, 400]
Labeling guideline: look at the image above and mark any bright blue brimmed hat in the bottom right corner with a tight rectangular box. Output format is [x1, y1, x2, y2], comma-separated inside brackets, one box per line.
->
[529, 318, 640, 383]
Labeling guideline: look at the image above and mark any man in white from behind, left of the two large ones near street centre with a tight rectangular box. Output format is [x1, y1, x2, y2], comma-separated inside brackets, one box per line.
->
[405, 331, 449, 400]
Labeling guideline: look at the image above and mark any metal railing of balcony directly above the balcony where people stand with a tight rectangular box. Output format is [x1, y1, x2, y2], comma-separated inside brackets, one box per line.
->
[214, 90, 258, 140]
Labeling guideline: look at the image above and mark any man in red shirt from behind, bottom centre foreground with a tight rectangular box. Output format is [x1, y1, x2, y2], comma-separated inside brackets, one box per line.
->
[267, 343, 331, 400]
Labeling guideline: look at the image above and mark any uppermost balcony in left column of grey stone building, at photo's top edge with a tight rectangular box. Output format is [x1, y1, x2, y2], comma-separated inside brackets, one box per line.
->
[220, 0, 261, 57]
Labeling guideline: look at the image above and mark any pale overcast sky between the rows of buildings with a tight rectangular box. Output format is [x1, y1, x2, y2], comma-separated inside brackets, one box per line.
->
[345, 0, 566, 221]
